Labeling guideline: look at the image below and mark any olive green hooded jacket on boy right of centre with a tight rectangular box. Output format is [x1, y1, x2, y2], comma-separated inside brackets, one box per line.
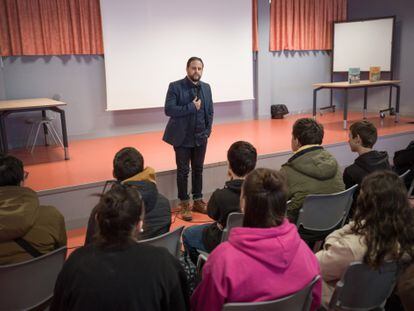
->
[281, 146, 345, 223]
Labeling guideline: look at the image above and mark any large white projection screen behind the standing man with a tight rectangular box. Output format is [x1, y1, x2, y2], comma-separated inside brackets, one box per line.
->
[101, 0, 253, 110]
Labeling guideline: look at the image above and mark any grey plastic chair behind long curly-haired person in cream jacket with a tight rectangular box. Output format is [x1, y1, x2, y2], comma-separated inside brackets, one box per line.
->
[329, 262, 398, 310]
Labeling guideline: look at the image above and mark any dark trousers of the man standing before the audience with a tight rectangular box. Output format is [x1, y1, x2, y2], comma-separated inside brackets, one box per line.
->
[174, 143, 207, 201]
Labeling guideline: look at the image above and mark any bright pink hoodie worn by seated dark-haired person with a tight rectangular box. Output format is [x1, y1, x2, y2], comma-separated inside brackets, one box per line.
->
[191, 219, 321, 311]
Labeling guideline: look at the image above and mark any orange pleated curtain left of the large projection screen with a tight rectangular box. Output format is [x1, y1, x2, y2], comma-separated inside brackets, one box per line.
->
[0, 0, 103, 56]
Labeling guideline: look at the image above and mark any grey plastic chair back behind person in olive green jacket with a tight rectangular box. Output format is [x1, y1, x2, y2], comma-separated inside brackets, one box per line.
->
[297, 185, 358, 249]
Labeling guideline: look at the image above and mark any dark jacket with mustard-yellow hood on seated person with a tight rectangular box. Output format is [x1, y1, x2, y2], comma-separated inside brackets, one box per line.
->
[85, 167, 171, 245]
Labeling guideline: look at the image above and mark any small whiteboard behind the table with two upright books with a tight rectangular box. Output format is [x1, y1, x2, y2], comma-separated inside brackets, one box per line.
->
[333, 17, 394, 72]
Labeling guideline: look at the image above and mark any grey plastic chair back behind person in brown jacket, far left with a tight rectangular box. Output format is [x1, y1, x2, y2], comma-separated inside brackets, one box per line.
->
[0, 246, 66, 311]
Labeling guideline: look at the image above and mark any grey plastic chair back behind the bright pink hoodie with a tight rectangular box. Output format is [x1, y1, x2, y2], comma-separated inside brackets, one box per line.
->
[222, 275, 320, 311]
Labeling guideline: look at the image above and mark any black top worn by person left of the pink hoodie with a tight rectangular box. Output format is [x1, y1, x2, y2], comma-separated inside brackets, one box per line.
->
[50, 241, 189, 311]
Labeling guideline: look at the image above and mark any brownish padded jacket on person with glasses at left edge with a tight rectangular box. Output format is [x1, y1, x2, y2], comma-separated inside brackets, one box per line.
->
[0, 186, 67, 265]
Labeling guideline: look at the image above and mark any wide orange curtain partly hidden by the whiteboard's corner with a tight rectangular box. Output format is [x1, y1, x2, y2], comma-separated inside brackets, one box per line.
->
[269, 0, 347, 51]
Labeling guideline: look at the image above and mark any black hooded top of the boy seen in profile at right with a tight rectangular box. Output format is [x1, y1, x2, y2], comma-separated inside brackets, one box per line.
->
[343, 150, 391, 189]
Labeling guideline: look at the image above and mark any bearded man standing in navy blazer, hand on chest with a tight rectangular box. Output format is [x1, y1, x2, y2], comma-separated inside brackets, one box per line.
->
[163, 57, 213, 221]
